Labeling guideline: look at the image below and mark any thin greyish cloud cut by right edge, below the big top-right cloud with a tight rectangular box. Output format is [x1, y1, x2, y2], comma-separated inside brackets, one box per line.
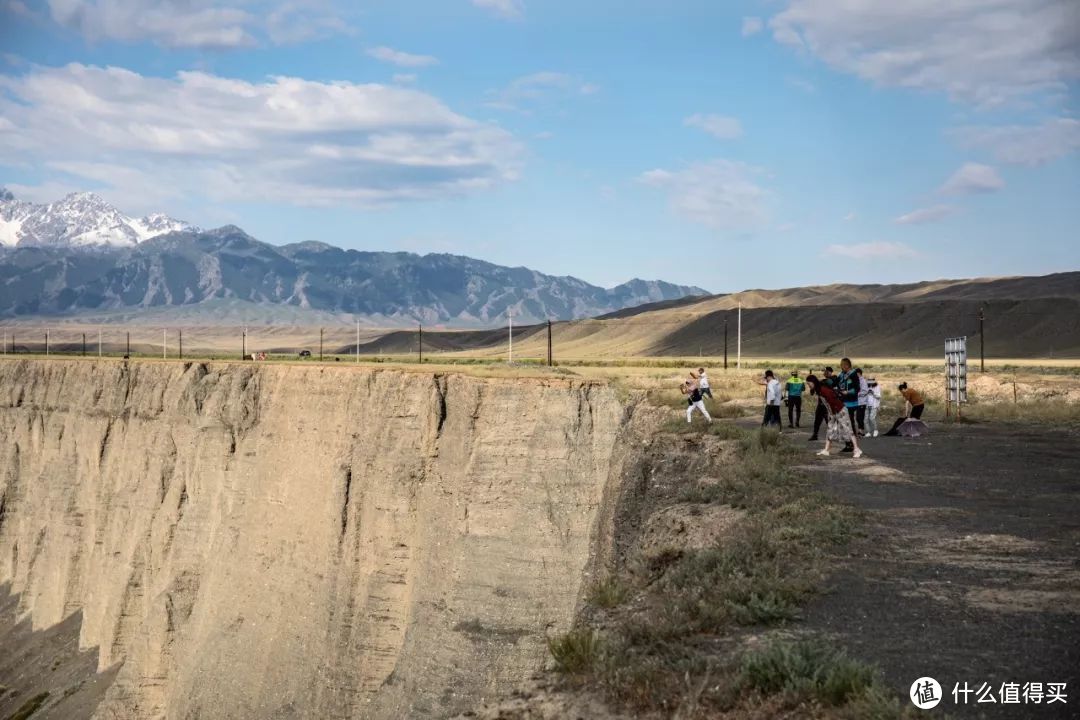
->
[949, 118, 1080, 165]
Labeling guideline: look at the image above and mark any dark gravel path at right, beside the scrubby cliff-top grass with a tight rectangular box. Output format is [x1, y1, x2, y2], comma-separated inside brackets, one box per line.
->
[794, 423, 1080, 718]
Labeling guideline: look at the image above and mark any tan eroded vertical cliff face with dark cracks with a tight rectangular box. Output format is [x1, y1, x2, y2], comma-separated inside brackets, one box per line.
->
[0, 359, 624, 720]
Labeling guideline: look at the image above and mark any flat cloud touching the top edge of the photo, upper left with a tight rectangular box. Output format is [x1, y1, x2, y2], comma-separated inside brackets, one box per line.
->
[39, 0, 349, 49]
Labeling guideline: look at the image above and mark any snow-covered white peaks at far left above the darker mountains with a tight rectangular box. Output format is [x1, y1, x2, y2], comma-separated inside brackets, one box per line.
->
[0, 188, 197, 247]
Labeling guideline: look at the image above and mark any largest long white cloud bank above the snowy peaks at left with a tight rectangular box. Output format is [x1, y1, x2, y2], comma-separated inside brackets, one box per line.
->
[0, 64, 521, 212]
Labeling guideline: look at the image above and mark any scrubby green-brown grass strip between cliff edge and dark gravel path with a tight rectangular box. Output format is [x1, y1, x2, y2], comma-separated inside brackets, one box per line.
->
[550, 418, 902, 719]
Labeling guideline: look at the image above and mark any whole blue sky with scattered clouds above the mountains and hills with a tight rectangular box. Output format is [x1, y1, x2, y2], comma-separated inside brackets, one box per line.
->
[0, 0, 1080, 293]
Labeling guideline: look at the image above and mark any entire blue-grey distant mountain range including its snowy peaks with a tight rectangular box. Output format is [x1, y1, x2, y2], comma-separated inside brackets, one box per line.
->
[0, 189, 706, 327]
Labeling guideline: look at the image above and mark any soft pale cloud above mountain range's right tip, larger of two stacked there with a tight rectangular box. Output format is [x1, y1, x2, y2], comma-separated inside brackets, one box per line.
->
[638, 160, 770, 230]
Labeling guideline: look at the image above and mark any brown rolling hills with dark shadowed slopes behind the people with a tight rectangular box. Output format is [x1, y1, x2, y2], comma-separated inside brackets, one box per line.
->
[347, 272, 1080, 358]
